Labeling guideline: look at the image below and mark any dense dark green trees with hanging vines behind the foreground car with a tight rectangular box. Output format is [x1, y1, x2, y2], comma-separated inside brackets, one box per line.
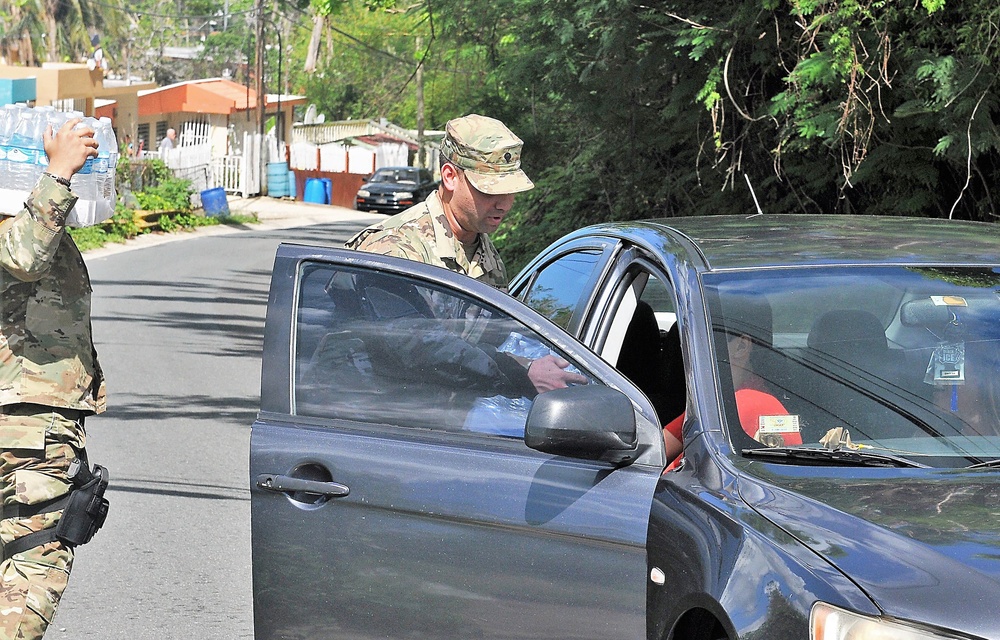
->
[480, 0, 1000, 265]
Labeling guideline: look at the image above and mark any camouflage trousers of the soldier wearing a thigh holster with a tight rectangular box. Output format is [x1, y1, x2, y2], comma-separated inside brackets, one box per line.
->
[0, 404, 86, 640]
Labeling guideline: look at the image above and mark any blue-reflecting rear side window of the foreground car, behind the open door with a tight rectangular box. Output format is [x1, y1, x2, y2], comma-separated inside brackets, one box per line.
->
[522, 250, 601, 329]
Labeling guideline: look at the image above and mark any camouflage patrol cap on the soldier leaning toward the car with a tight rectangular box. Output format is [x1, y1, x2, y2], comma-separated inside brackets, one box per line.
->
[441, 113, 535, 195]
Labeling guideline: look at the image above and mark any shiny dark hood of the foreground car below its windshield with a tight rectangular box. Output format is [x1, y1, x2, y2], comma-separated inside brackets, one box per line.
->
[740, 462, 1000, 637]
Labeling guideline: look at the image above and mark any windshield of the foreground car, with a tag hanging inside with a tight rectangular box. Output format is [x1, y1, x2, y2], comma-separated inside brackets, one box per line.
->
[705, 267, 1000, 467]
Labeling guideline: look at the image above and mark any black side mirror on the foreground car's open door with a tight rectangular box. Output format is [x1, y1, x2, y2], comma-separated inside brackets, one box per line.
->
[524, 385, 638, 464]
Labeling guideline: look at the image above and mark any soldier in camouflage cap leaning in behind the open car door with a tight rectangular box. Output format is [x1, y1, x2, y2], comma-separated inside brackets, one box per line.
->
[345, 114, 586, 393]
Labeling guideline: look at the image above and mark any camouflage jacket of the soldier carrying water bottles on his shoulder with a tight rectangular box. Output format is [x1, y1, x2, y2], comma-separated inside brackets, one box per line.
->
[0, 176, 105, 413]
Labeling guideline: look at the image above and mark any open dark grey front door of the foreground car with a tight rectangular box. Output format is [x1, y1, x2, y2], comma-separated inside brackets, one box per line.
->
[250, 245, 664, 640]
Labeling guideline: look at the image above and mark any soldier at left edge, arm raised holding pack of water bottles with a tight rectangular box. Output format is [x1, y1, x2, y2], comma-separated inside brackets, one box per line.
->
[0, 120, 105, 640]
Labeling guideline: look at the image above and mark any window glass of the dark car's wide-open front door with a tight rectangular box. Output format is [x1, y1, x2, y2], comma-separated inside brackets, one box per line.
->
[293, 262, 592, 438]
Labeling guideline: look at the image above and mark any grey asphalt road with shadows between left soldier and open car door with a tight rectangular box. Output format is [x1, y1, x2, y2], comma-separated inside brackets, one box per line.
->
[46, 214, 375, 640]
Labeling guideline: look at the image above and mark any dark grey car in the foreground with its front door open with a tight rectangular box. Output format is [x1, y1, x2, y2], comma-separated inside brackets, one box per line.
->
[250, 216, 1000, 640]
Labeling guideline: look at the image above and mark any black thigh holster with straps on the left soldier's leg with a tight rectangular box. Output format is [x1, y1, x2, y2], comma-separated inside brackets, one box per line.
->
[3, 453, 110, 560]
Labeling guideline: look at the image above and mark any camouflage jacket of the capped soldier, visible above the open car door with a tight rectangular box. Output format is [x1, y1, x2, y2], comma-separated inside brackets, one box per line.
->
[345, 191, 507, 292]
